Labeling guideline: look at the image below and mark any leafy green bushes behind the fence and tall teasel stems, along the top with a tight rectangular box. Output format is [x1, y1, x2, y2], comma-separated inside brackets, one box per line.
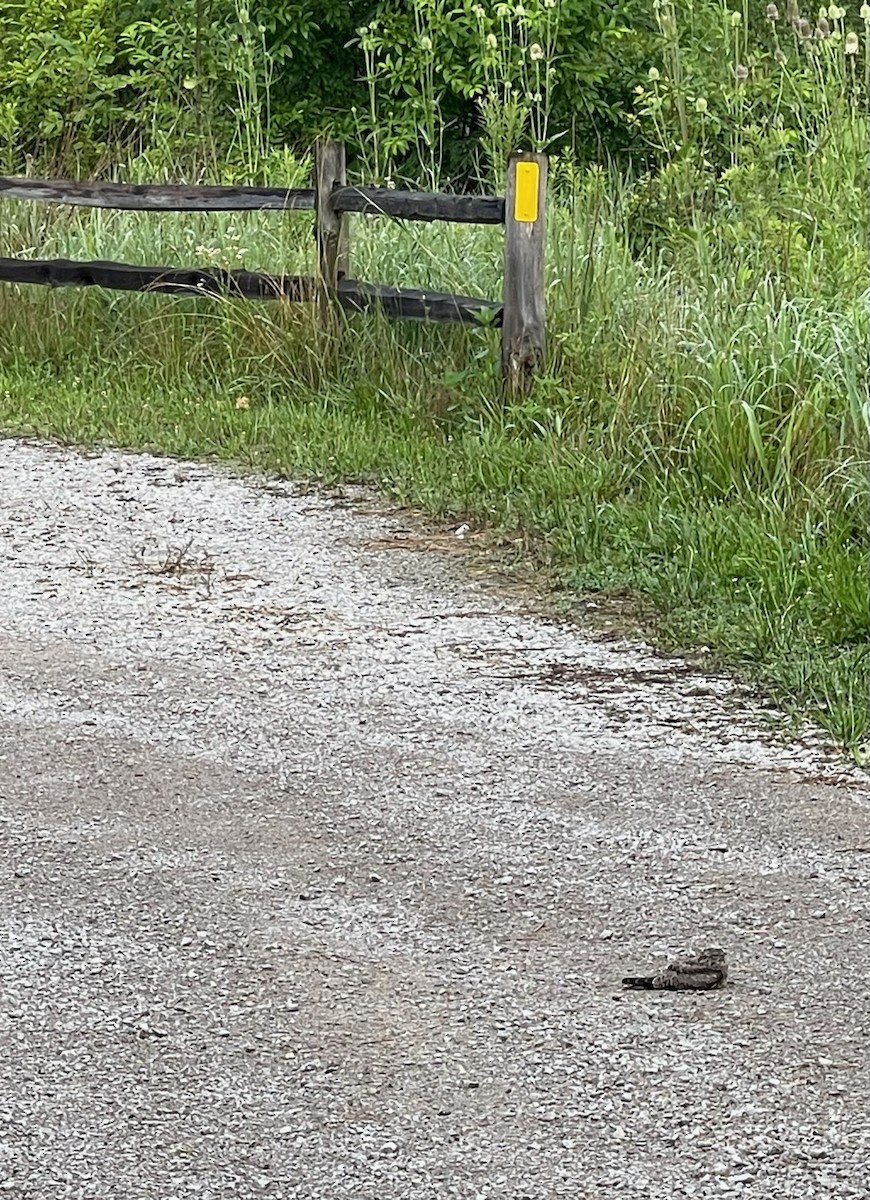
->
[0, 0, 652, 170]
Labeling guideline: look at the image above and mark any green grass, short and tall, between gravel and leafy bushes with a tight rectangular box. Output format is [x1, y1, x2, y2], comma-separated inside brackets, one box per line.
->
[0, 173, 870, 750]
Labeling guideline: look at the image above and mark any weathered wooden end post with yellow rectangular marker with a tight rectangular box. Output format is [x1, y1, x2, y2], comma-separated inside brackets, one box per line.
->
[502, 154, 547, 397]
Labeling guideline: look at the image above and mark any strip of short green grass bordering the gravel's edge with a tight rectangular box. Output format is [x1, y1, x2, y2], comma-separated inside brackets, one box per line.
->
[0, 301, 868, 749]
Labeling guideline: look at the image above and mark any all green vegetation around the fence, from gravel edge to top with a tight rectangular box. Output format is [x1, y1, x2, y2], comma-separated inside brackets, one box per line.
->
[0, 0, 870, 749]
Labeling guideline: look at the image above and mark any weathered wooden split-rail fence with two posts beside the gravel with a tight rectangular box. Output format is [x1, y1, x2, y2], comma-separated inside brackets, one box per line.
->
[0, 140, 547, 395]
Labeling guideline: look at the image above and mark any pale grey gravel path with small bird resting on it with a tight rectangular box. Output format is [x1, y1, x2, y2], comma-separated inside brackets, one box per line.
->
[0, 440, 870, 1200]
